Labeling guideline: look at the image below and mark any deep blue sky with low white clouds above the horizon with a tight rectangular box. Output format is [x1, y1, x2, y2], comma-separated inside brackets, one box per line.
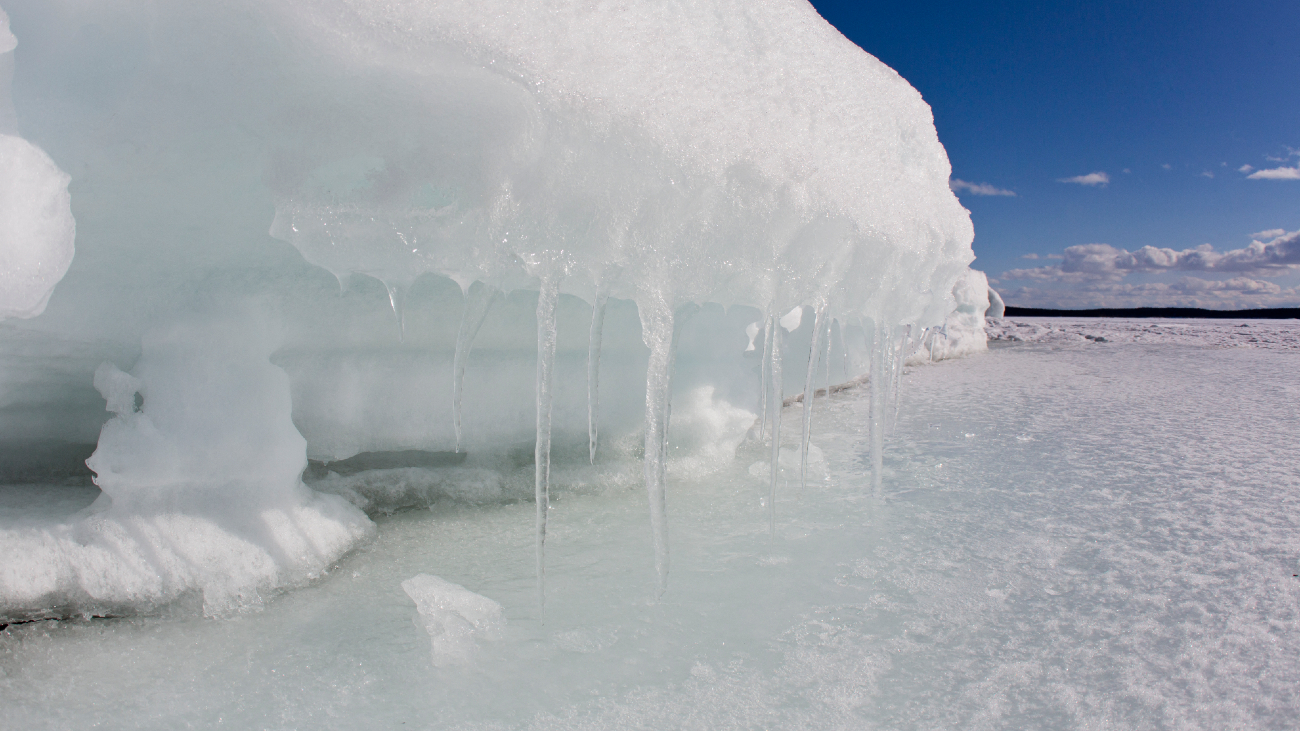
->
[813, 0, 1300, 308]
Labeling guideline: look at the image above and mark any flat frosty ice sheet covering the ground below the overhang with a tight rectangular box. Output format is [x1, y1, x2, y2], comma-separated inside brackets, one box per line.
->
[0, 336, 1300, 728]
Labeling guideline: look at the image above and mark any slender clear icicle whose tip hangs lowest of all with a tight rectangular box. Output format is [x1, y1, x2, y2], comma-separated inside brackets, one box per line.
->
[533, 271, 560, 615]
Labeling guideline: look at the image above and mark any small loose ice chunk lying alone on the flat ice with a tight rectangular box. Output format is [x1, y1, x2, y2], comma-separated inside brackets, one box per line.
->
[402, 574, 506, 667]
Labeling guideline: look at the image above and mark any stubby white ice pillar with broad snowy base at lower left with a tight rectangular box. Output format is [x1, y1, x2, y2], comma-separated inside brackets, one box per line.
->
[0, 309, 374, 618]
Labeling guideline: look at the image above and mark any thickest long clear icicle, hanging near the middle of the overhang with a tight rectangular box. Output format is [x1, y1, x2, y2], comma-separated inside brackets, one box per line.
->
[641, 300, 673, 596]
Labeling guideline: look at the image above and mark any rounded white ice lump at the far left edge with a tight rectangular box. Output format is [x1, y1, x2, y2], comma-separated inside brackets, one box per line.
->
[0, 133, 75, 320]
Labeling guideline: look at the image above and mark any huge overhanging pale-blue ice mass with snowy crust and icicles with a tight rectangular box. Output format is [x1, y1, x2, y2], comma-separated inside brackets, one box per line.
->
[0, 0, 983, 613]
